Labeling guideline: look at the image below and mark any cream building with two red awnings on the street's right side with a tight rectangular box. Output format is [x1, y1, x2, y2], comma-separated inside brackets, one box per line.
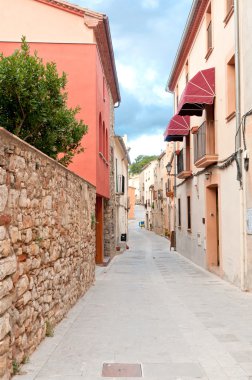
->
[163, 0, 251, 288]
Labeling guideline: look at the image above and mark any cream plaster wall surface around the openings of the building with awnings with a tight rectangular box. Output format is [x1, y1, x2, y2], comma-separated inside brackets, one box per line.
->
[171, 0, 242, 285]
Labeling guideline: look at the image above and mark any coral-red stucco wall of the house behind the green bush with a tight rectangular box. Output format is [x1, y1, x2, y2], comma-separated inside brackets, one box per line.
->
[0, 42, 110, 198]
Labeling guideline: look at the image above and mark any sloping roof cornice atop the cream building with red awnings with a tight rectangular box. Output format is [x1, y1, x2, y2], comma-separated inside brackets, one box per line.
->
[166, 0, 209, 92]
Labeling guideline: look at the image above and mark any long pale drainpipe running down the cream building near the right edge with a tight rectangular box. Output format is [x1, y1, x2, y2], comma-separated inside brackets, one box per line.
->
[234, 0, 247, 291]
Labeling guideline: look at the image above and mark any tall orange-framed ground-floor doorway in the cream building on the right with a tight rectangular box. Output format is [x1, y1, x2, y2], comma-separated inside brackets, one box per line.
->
[206, 185, 220, 269]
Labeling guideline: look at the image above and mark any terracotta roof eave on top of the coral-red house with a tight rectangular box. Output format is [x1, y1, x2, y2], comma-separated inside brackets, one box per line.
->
[34, 0, 121, 104]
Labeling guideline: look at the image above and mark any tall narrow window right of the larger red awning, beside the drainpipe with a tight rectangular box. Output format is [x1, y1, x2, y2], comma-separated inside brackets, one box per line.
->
[226, 55, 236, 121]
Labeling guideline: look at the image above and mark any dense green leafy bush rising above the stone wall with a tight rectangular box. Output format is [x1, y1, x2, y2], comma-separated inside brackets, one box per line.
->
[0, 37, 87, 166]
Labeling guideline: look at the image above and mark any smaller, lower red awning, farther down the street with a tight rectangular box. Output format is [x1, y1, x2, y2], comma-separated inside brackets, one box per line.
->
[164, 115, 190, 141]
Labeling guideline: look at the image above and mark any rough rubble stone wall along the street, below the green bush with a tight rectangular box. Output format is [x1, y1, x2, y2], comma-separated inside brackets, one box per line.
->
[0, 128, 95, 379]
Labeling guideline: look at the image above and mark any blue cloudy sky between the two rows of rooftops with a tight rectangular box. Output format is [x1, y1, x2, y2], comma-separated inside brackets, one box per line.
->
[76, 0, 192, 160]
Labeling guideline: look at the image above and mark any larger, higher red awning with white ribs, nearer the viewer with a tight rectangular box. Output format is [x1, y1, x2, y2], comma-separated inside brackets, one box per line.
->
[177, 68, 215, 116]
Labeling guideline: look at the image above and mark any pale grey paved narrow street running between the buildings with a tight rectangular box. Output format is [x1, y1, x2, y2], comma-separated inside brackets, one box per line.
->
[14, 206, 252, 380]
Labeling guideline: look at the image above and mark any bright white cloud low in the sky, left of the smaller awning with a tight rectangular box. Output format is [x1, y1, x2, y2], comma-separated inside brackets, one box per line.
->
[127, 133, 166, 162]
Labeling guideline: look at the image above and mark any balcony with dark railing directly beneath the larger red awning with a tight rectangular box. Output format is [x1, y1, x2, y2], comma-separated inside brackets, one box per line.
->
[194, 121, 218, 168]
